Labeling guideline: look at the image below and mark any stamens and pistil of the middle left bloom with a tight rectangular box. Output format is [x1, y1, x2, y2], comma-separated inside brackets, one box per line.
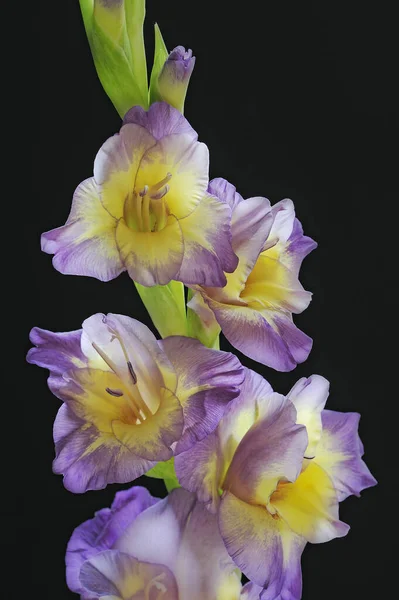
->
[92, 328, 153, 425]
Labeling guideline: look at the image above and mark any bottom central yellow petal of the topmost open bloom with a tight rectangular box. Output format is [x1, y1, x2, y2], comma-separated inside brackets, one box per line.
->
[116, 215, 184, 286]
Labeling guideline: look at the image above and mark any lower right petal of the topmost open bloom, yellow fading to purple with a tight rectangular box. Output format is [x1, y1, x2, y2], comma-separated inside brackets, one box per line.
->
[177, 195, 238, 287]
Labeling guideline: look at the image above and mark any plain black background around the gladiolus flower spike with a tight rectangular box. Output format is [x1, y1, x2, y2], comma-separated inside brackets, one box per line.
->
[22, 0, 398, 600]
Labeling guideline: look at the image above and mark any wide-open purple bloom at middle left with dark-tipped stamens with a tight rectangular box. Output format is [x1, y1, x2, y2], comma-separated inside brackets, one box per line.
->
[27, 314, 244, 492]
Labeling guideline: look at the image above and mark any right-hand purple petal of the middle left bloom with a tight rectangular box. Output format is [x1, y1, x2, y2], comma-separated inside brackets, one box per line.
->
[159, 336, 244, 454]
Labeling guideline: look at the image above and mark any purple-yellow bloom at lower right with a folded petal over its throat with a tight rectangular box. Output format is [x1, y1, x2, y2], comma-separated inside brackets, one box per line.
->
[175, 370, 376, 600]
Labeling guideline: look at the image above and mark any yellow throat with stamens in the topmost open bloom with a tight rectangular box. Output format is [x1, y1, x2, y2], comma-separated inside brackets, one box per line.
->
[123, 173, 172, 232]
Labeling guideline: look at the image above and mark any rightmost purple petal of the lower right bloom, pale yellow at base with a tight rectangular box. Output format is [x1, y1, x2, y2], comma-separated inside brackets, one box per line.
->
[315, 410, 377, 502]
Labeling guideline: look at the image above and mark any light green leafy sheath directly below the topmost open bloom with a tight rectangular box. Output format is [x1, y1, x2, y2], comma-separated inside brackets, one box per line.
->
[135, 281, 187, 338]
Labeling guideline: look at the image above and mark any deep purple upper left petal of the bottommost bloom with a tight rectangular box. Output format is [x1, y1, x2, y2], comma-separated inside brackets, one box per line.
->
[65, 486, 158, 594]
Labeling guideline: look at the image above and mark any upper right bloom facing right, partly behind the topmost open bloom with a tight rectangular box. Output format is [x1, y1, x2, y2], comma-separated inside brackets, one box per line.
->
[188, 179, 316, 371]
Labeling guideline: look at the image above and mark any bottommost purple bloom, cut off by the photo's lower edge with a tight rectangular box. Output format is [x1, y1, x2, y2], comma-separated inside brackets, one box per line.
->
[66, 487, 259, 600]
